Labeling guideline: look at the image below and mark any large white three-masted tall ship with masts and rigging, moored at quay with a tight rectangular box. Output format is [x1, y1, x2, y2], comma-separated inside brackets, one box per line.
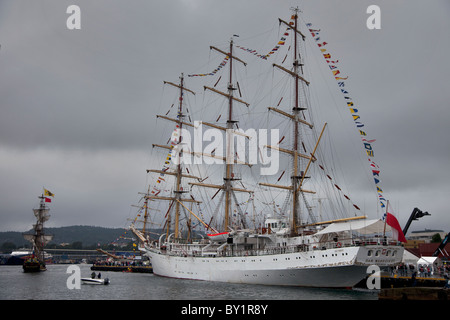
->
[131, 9, 403, 287]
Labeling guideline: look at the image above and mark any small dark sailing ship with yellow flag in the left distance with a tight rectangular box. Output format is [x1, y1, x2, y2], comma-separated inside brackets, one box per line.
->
[23, 189, 54, 272]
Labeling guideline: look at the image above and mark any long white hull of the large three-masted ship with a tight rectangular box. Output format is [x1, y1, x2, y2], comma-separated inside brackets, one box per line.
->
[146, 246, 403, 288]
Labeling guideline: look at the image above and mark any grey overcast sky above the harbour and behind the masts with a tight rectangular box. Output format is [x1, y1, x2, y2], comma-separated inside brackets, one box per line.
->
[0, 0, 450, 235]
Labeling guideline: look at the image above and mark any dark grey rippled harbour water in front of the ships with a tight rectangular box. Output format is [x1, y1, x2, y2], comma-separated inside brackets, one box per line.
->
[0, 264, 378, 301]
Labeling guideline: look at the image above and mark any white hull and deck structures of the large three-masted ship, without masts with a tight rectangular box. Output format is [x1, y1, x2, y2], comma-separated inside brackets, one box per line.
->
[142, 220, 403, 288]
